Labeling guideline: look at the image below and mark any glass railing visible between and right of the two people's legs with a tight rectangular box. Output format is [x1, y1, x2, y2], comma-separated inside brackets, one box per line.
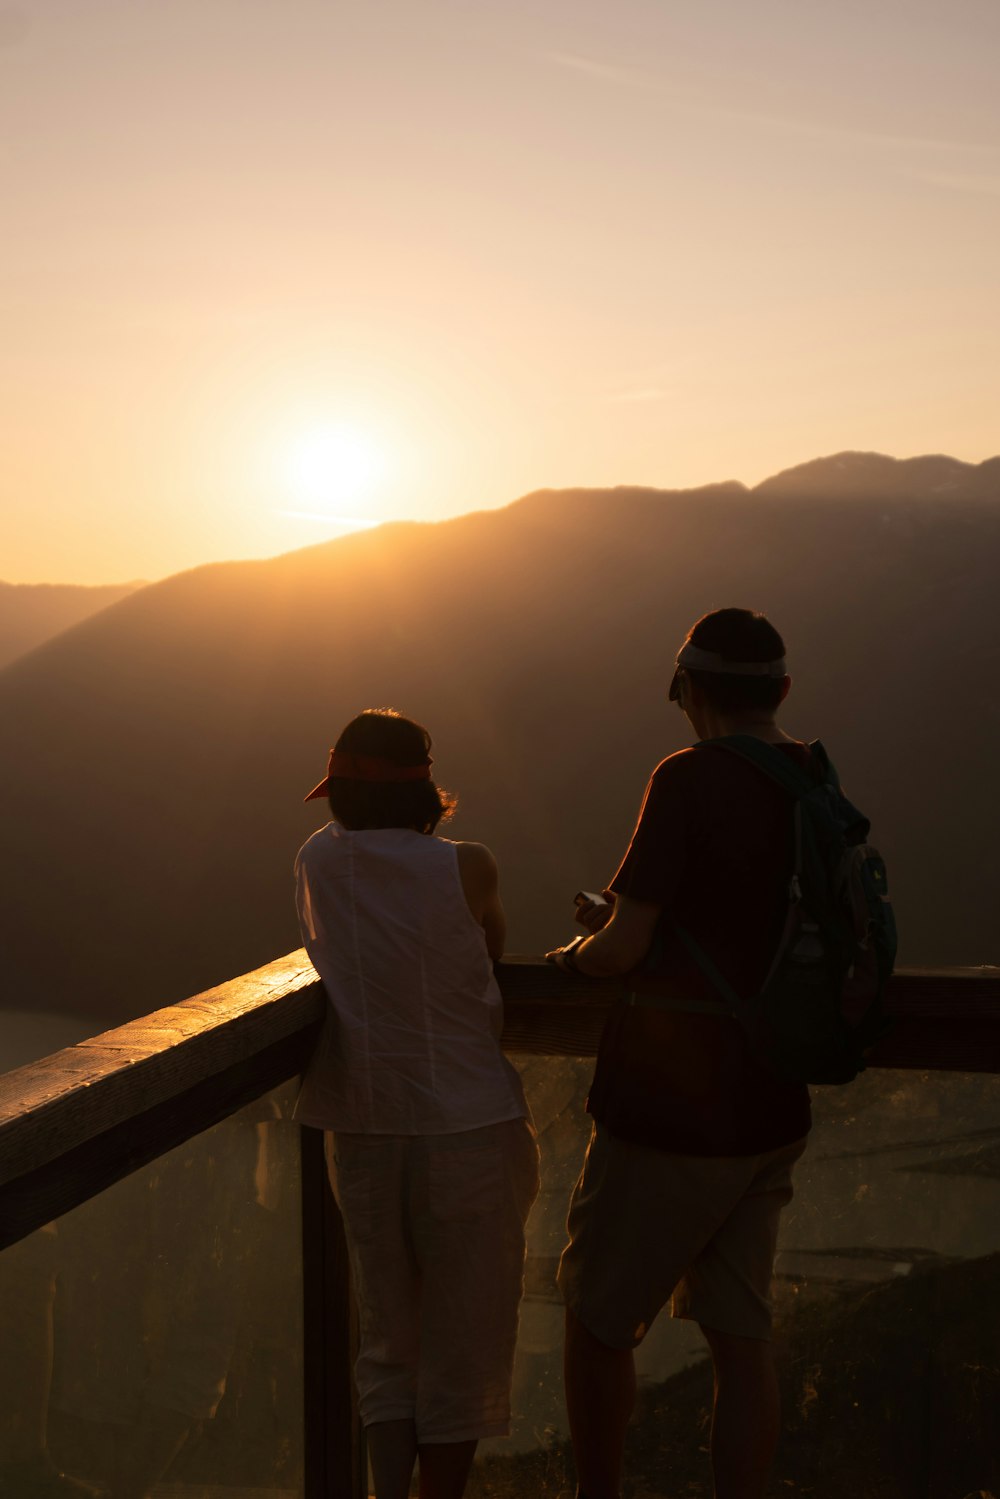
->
[469, 1058, 1000, 1499]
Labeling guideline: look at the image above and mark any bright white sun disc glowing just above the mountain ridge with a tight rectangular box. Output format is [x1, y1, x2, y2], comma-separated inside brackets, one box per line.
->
[279, 423, 390, 526]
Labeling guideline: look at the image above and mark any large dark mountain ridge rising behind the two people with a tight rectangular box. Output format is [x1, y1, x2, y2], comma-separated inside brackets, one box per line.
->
[0, 454, 1000, 1022]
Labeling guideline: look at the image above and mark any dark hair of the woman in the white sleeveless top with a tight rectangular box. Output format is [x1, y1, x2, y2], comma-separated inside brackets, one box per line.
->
[328, 708, 457, 833]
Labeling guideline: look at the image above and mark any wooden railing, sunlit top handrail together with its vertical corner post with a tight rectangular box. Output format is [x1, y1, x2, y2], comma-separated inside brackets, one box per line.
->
[0, 950, 1000, 1499]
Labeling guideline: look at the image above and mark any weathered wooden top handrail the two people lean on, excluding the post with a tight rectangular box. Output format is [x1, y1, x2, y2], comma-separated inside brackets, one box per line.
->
[0, 949, 1000, 1186]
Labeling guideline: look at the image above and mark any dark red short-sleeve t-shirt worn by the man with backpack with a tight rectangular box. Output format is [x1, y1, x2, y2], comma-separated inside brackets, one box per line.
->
[588, 742, 810, 1156]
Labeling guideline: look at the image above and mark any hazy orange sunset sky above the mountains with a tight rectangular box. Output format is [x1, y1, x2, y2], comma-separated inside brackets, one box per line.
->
[0, 0, 1000, 583]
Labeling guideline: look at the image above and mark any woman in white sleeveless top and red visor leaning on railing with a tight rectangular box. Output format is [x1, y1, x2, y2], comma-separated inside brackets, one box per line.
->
[295, 709, 538, 1499]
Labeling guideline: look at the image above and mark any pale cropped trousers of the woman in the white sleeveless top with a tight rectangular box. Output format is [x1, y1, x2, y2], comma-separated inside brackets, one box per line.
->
[327, 1118, 538, 1442]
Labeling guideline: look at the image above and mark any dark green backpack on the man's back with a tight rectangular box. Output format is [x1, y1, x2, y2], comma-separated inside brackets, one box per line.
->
[675, 735, 897, 1082]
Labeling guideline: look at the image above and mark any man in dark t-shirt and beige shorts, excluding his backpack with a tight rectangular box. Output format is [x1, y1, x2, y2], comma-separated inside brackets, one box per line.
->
[549, 609, 811, 1499]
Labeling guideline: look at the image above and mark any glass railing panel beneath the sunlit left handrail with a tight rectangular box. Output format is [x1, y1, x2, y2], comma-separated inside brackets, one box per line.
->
[0, 1085, 303, 1499]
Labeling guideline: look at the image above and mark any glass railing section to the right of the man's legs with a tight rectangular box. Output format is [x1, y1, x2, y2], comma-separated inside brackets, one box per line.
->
[774, 1070, 1000, 1499]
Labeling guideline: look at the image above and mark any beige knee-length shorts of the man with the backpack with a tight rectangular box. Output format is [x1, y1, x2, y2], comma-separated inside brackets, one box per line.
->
[559, 1124, 805, 1348]
